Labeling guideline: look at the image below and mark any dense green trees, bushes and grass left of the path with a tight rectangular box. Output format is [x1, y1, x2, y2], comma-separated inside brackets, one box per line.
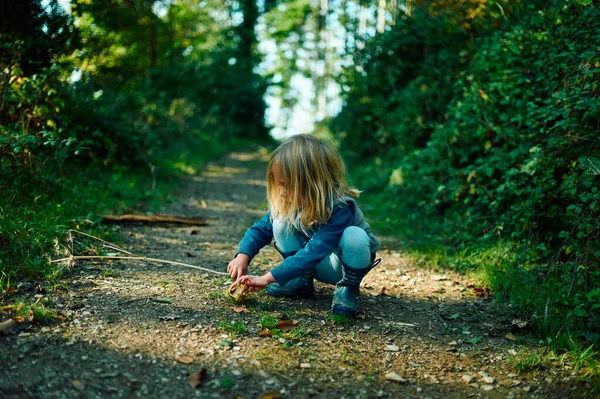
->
[0, 0, 268, 285]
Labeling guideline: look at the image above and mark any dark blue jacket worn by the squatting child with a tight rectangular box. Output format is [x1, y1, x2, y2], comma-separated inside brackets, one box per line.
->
[237, 197, 381, 286]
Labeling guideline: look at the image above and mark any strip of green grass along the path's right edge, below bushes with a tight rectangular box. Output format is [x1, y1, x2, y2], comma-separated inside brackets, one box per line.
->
[360, 189, 600, 378]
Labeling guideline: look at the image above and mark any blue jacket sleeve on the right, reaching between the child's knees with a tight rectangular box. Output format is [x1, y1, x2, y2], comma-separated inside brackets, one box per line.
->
[271, 204, 354, 286]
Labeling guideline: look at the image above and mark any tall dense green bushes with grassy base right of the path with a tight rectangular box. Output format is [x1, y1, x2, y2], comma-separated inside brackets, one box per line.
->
[332, 0, 600, 354]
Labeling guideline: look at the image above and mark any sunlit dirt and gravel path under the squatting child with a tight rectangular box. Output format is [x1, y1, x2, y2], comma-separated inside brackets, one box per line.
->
[0, 154, 586, 399]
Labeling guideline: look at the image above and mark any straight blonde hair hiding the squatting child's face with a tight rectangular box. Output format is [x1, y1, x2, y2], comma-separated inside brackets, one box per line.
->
[267, 134, 360, 227]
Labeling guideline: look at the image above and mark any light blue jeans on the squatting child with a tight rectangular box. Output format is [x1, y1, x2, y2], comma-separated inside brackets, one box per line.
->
[273, 219, 372, 284]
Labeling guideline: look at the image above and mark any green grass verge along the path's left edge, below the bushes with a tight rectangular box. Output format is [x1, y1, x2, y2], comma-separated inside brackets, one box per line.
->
[0, 139, 262, 291]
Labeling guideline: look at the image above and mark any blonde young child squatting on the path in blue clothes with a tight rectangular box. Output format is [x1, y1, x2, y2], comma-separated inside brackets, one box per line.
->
[227, 135, 381, 317]
